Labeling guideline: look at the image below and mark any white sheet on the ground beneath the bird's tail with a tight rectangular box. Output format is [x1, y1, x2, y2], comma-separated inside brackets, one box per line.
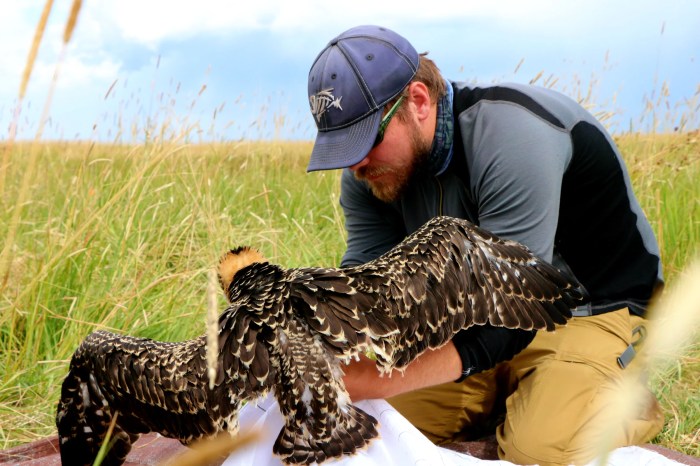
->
[223, 396, 680, 466]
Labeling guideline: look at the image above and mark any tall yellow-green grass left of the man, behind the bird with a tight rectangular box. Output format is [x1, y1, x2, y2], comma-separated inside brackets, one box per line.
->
[0, 143, 343, 447]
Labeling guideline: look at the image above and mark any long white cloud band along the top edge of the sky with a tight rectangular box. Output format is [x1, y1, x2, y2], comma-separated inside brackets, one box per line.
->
[69, 0, 612, 47]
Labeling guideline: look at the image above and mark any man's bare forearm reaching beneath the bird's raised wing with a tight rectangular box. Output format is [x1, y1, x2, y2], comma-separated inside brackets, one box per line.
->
[343, 341, 462, 401]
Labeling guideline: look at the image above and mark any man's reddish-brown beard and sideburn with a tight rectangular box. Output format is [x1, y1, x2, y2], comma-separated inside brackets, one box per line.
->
[355, 124, 432, 203]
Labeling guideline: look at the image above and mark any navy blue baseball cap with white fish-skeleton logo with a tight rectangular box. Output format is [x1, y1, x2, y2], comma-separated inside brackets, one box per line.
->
[307, 26, 419, 171]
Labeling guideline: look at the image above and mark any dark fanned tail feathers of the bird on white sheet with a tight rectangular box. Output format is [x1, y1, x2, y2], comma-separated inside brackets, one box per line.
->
[273, 405, 378, 464]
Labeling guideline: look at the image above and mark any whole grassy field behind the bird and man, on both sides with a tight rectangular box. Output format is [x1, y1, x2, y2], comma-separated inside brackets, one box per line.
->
[0, 133, 700, 456]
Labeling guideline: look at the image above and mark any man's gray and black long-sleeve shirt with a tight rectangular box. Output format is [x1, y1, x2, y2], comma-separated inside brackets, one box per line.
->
[340, 83, 661, 315]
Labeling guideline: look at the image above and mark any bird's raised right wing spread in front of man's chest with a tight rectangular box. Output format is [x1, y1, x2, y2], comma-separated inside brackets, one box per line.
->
[284, 217, 585, 371]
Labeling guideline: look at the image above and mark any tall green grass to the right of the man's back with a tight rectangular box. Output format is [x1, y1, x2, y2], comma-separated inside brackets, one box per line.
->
[620, 131, 700, 457]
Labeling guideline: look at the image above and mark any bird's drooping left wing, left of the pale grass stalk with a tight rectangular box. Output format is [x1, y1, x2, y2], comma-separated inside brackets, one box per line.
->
[56, 331, 216, 465]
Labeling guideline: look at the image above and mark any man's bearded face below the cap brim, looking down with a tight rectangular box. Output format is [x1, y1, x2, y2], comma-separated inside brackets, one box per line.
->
[350, 115, 432, 202]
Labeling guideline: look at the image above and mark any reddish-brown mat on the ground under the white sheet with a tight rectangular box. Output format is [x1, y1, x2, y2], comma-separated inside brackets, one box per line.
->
[0, 434, 700, 466]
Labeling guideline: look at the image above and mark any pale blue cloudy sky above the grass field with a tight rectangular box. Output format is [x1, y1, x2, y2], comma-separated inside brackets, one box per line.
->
[0, 0, 700, 142]
